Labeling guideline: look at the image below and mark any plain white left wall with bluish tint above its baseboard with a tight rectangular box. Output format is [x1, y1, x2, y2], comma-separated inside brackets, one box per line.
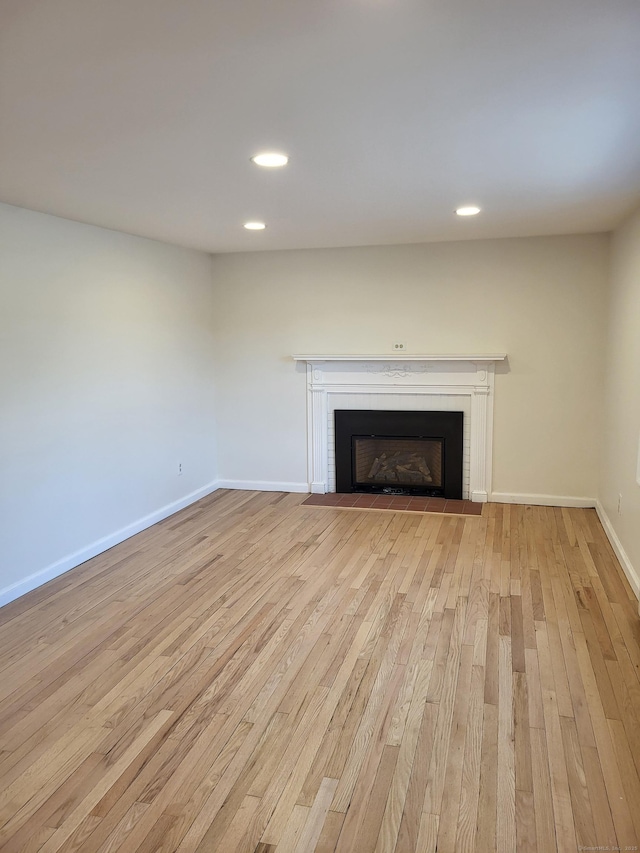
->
[0, 205, 216, 603]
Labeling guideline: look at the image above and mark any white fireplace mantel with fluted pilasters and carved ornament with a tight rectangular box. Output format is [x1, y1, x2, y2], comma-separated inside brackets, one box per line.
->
[293, 353, 506, 502]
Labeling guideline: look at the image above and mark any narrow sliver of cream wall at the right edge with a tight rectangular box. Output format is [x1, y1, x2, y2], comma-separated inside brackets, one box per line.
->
[598, 204, 640, 594]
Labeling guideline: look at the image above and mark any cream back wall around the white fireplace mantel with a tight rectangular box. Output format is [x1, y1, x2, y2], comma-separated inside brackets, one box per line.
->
[214, 235, 609, 499]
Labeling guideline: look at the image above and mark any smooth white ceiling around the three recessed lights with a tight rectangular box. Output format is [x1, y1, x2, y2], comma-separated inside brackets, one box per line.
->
[0, 0, 640, 252]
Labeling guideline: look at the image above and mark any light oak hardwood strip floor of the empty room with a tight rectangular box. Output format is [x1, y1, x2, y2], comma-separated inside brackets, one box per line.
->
[0, 491, 640, 853]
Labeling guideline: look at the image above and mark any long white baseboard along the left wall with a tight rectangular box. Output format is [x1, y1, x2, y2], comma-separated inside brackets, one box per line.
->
[0, 480, 220, 607]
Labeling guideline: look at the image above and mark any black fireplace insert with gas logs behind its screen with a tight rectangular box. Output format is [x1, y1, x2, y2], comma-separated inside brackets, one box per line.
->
[334, 409, 463, 500]
